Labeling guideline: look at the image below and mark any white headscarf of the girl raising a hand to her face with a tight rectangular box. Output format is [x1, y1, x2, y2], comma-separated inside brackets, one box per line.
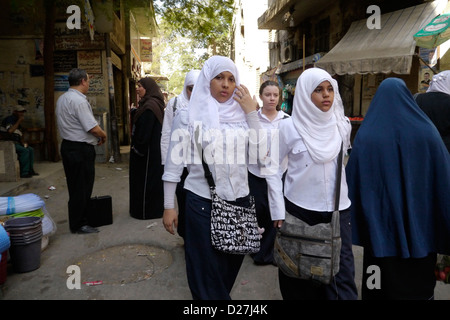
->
[188, 56, 246, 134]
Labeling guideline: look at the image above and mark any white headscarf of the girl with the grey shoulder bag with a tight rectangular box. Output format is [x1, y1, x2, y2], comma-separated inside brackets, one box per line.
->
[292, 68, 351, 163]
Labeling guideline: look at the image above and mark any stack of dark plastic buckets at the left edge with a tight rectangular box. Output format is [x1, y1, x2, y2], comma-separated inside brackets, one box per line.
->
[5, 217, 42, 273]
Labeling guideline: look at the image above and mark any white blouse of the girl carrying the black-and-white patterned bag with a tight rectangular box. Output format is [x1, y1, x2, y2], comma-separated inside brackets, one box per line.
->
[162, 110, 259, 209]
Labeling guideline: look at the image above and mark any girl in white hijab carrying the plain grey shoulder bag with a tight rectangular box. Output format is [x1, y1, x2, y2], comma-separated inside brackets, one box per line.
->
[274, 68, 358, 300]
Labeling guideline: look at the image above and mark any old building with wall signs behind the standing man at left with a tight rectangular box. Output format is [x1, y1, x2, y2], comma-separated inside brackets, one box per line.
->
[0, 0, 156, 162]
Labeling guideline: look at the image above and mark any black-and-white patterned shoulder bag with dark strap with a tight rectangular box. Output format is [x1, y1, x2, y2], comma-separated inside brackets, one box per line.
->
[197, 129, 261, 254]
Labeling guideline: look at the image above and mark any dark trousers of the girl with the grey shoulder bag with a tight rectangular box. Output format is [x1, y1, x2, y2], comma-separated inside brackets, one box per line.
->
[278, 198, 358, 300]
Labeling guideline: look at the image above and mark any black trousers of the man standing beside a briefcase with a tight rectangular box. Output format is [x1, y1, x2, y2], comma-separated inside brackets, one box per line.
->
[61, 140, 95, 232]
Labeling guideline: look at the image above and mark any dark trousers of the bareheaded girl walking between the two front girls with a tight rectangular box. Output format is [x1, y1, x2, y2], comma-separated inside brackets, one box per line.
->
[248, 172, 277, 264]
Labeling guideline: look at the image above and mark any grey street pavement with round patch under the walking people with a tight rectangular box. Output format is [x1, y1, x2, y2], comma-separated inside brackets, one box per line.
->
[0, 160, 450, 301]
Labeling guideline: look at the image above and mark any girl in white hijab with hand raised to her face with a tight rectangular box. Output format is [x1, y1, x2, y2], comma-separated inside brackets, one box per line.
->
[163, 56, 259, 300]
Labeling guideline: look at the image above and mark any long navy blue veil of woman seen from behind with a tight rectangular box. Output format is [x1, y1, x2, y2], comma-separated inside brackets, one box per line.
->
[346, 78, 450, 258]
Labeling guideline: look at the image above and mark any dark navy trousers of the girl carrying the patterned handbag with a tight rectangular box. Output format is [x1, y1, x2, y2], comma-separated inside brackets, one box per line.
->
[184, 190, 245, 300]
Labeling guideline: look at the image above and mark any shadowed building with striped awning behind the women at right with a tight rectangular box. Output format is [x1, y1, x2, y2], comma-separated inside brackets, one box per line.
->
[258, 0, 448, 125]
